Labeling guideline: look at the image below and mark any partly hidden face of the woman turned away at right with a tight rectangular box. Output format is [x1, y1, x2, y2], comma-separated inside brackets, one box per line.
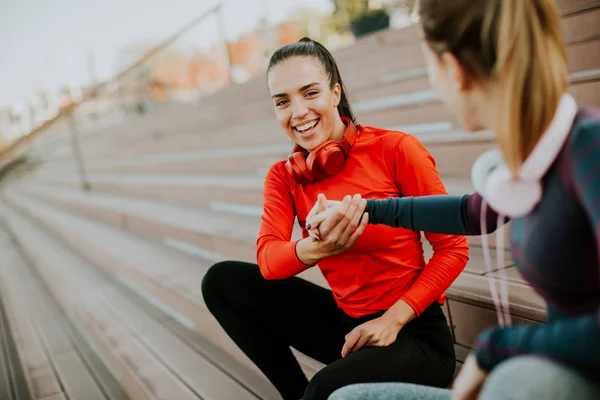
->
[421, 42, 486, 131]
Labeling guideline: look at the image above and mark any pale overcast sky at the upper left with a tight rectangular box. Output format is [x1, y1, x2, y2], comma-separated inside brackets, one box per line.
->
[0, 0, 332, 109]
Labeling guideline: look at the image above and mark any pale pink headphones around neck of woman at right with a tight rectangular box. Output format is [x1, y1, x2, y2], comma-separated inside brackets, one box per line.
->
[471, 94, 577, 218]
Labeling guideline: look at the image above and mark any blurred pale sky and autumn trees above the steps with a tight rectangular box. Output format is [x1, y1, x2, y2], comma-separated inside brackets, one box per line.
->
[0, 0, 415, 147]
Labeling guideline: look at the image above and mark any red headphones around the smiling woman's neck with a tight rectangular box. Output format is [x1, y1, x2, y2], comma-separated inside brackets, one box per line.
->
[285, 117, 360, 184]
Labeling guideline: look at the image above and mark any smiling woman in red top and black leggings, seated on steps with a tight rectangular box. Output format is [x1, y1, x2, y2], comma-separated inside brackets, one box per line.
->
[202, 38, 468, 400]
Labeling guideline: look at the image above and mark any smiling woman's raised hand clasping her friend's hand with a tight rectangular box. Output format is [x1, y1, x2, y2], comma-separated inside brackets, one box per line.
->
[311, 195, 369, 258]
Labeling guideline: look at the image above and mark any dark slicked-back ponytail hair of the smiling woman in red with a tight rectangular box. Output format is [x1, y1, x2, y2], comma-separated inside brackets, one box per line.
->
[267, 37, 356, 123]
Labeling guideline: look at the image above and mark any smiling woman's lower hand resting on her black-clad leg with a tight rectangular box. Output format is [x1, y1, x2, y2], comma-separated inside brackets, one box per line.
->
[342, 314, 402, 357]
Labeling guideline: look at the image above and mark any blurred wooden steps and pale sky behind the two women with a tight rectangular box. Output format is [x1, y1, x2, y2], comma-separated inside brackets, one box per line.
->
[0, 0, 600, 400]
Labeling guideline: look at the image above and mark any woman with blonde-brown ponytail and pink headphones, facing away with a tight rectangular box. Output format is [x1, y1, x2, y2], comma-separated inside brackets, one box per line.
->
[314, 0, 600, 400]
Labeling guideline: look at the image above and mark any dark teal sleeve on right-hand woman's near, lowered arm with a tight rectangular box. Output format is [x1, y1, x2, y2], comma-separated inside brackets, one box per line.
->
[475, 120, 600, 379]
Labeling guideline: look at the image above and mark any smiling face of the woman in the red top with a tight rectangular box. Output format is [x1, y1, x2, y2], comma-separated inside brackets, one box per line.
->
[268, 57, 341, 151]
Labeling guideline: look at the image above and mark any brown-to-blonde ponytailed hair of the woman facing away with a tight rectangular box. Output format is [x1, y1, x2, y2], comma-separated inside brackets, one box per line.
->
[419, 0, 568, 173]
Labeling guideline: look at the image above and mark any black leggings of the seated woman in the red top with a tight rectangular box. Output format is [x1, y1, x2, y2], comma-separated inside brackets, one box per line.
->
[202, 261, 456, 400]
